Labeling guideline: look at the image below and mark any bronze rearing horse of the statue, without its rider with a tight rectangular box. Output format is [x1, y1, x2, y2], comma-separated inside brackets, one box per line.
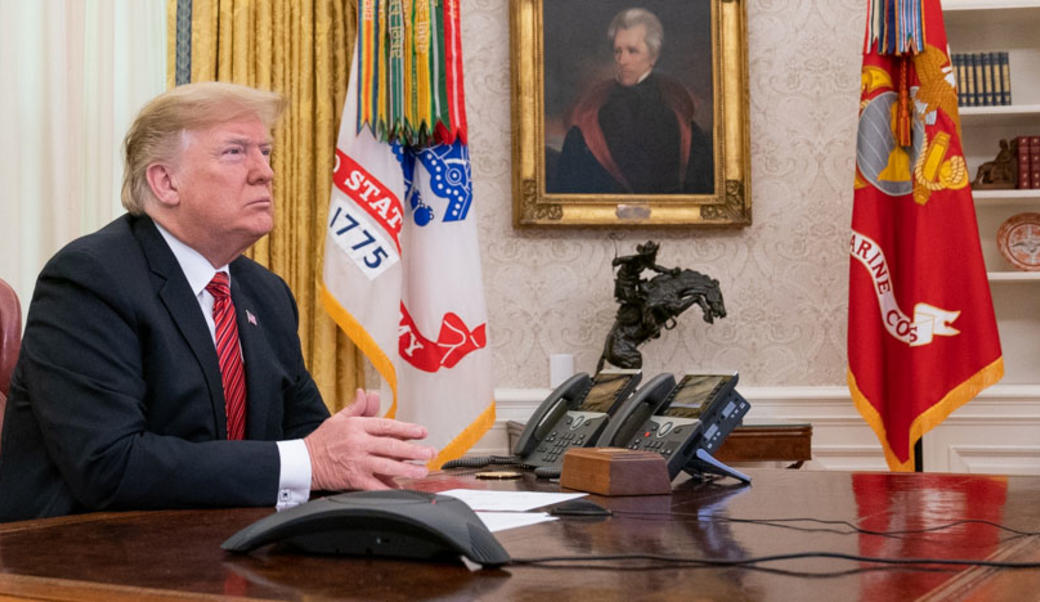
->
[596, 269, 726, 372]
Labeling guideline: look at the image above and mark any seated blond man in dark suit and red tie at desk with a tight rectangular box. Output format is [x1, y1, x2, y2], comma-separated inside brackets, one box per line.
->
[0, 82, 435, 521]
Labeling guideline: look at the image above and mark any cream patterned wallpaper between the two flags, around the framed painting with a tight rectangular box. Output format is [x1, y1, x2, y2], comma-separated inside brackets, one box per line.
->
[462, 0, 865, 388]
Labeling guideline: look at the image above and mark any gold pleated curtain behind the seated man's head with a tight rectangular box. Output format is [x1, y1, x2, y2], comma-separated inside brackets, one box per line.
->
[167, 0, 364, 411]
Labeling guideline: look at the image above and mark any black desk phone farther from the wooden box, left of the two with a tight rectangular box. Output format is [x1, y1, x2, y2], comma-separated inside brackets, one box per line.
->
[513, 370, 642, 467]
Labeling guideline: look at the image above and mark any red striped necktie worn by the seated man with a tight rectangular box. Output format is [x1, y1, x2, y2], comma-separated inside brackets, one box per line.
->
[206, 271, 245, 439]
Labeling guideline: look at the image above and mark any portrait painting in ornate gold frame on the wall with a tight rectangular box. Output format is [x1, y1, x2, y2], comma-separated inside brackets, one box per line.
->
[511, 0, 751, 227]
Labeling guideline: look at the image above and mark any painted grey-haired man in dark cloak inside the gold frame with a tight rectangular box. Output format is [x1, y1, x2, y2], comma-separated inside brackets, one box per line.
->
[548, 8, 714, 194]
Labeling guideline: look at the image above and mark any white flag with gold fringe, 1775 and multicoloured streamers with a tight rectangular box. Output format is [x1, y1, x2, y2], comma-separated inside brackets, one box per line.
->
[322, 0, 495, 468]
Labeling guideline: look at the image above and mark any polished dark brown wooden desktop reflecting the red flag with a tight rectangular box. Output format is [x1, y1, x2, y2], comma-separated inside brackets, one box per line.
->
[0, 469, 1040, 602]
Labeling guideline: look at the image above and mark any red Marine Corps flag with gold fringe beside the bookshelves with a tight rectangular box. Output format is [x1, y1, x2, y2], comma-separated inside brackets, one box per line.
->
[848, 0, 1004, 470]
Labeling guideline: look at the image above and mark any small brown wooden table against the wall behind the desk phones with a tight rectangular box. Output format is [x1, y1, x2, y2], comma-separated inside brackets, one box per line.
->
[505, 420, 812, 468]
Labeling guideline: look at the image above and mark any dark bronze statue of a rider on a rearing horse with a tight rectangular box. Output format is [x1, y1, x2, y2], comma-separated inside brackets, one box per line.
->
[596, 240, 726, 372]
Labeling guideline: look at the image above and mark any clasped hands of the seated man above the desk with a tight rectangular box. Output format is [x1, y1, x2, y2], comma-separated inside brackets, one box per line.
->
[304, 389, 437, 491]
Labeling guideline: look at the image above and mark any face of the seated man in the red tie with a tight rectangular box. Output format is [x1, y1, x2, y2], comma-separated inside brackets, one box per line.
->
[176, 116, 275, 261]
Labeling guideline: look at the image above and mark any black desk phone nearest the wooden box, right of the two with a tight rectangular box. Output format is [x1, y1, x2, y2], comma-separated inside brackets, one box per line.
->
[596, 372, 751, 482]
